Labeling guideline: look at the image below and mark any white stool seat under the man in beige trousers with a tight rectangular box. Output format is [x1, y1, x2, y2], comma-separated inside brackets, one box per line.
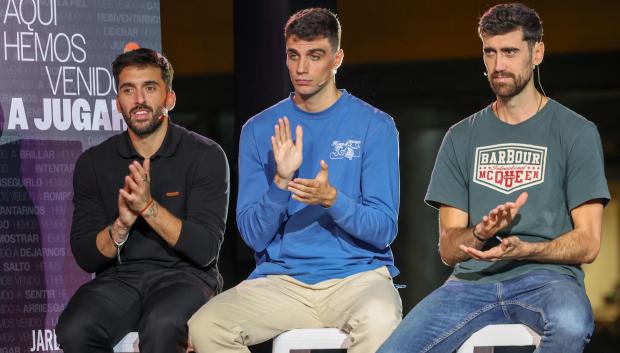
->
[272, 328, 349, 353]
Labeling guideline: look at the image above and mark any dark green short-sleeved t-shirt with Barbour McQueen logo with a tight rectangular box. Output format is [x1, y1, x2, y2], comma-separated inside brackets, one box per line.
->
[425, 99, 609, 284]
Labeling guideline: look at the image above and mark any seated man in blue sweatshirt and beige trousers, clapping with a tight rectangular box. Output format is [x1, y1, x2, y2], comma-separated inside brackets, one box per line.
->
[189, 8, 402, 353]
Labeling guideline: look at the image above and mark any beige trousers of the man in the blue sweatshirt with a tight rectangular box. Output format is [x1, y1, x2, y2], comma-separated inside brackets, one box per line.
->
[188, 267, 402, 353]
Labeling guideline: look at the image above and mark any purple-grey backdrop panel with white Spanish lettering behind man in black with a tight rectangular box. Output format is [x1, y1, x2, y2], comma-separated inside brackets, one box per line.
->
[0, 0, 161, 353]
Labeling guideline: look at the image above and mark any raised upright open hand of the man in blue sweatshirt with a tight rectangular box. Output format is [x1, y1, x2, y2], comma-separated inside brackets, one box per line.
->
[271, 117, 303, 190]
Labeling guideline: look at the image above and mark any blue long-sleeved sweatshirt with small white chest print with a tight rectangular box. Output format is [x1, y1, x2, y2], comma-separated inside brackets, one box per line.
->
[237, 91, 400, 284]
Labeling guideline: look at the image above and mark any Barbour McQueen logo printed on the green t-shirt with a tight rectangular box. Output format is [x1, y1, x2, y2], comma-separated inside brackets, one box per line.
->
[473, 143, 547, 194]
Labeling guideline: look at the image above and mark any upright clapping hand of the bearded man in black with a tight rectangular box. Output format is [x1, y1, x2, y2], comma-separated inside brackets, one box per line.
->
[119, 158, 152, 214]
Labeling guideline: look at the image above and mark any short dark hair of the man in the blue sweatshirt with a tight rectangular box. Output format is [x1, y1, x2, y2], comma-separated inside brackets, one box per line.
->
[284, 7, 342, 51]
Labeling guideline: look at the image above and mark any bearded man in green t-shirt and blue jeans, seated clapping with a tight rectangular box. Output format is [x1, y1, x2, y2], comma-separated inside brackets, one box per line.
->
[379, 4, 609, 353]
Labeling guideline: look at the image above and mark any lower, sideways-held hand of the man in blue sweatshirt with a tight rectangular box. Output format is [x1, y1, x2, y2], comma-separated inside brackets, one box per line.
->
[288, 160, 338, 207]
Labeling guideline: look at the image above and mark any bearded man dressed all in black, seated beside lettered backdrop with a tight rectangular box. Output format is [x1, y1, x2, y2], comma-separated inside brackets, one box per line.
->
[56, 49, 229, 353]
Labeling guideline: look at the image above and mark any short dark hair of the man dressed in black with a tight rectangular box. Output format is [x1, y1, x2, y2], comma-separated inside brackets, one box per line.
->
[112, 48, 174, 90]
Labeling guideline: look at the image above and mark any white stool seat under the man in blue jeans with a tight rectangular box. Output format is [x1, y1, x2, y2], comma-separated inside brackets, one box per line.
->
[457, 324, 540, 353]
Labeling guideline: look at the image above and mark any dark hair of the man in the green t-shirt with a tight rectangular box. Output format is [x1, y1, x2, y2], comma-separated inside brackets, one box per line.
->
[478, 3, 543, 46]
